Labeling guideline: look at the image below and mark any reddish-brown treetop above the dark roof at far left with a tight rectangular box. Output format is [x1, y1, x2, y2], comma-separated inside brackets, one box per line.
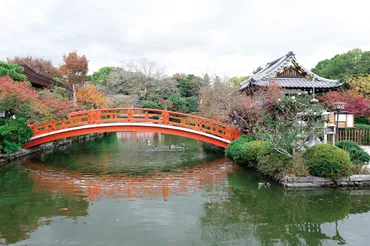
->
[7, 56, 58, 78]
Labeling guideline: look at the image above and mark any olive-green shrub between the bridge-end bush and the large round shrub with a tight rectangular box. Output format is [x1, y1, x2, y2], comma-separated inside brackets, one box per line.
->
[257, 145, 292, 175]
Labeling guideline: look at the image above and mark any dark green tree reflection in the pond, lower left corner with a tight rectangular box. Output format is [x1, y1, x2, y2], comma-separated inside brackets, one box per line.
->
[0, 166, 89, 244]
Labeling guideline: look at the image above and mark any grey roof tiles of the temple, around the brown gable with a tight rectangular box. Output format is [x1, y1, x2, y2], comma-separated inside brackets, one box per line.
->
[240, 51, 343, 90]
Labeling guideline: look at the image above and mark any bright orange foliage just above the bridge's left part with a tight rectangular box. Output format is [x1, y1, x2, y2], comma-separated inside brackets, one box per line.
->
[76, 85, 108, 108]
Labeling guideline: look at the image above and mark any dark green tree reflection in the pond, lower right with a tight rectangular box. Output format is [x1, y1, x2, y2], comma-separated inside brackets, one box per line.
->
[201, 172, 370, 245]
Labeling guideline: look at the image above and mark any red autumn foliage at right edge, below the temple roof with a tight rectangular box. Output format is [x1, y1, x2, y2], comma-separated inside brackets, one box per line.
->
[319, 90, 370, 116]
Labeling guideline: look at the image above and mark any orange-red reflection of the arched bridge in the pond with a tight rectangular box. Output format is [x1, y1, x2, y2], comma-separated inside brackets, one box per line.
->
[23, 158, 236, 201]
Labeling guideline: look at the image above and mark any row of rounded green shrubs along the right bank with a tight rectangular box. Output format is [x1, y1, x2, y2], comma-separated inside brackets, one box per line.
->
[225, 135, 362, 178]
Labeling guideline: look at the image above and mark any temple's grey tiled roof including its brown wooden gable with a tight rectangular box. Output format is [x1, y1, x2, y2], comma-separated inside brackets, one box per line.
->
[240, 51, 343, 93]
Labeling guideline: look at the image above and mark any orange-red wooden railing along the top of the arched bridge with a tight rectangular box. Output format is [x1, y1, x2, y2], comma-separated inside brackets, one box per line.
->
[30, 108, 239, 140]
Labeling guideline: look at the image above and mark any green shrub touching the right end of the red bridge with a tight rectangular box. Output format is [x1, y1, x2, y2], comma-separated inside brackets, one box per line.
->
[225, 134, 254, 164]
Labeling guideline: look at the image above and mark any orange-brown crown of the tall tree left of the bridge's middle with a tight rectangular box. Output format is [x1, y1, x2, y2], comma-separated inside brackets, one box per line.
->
[58, 51, 89, 85]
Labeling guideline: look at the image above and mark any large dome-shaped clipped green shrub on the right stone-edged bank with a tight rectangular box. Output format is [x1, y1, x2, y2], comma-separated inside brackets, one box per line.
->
[304, 144, 352, 178]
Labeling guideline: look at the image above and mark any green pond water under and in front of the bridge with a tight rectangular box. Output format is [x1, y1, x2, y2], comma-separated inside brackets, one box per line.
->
[0, 133, 370, 246]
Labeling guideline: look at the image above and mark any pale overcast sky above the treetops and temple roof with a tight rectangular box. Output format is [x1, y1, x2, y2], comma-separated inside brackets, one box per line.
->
[0, 0, 370, 76]
